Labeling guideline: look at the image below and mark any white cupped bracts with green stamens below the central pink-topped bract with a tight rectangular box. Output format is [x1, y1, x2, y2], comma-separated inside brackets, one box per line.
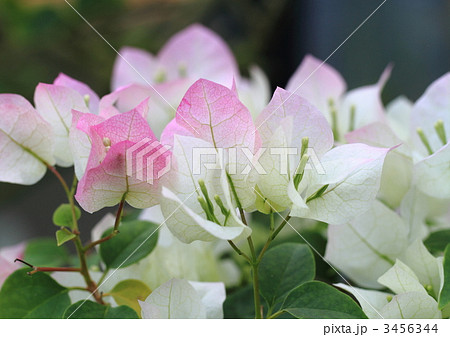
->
[161, 135, 251, 243]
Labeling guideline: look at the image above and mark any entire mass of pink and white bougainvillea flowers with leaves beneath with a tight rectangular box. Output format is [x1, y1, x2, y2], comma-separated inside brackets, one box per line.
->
[0, 25, 450, 318]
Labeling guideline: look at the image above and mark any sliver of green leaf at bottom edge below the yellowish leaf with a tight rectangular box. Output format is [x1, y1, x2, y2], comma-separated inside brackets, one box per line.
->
[64, 301, 139, 319]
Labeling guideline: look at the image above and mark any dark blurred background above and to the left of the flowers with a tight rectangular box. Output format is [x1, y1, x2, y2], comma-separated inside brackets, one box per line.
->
[0, 0, 450, 246]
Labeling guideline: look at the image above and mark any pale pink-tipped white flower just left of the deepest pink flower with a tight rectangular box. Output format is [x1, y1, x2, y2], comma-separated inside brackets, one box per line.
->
[34, 74, 99, 167]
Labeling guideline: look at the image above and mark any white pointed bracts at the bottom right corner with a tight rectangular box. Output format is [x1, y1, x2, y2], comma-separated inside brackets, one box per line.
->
[336, 239, 443, 319]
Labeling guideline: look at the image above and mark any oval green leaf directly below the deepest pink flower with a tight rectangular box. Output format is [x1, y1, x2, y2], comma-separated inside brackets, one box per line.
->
[100, 221, 158, 268]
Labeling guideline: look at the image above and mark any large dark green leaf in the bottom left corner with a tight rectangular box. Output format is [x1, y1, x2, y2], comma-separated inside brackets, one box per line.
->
[0, 268, 70, 318]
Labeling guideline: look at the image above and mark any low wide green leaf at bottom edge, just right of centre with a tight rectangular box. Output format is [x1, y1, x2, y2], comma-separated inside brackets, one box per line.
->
[283, 281, 367, 319]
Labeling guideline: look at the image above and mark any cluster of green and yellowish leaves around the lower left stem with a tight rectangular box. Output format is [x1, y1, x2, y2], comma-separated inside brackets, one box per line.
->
[0, 218, 158, 318]
